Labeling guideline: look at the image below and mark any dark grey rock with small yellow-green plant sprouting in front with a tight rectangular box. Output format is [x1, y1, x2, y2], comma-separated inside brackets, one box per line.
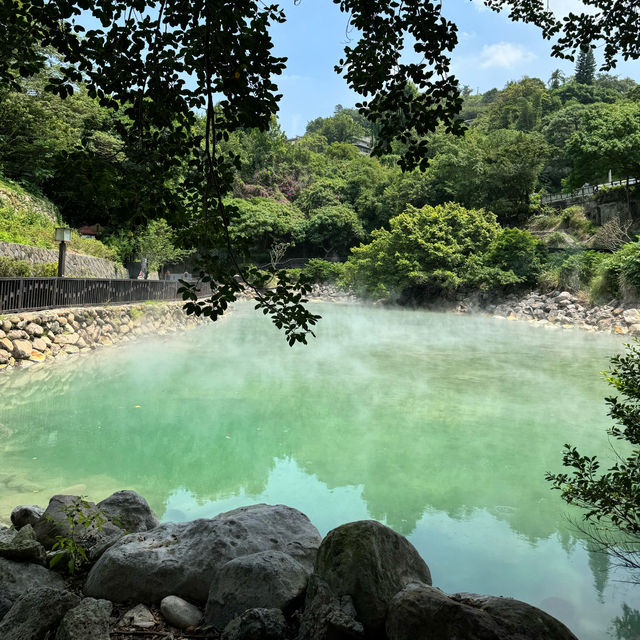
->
[34, 494, 122, 550]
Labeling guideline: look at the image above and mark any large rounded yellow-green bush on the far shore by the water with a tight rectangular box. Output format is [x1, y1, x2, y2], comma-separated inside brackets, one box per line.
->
[345, 202, 540, 298]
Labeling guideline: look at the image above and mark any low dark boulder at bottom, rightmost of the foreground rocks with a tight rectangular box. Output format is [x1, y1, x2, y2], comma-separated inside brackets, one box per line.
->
[386, 584, 577, 640]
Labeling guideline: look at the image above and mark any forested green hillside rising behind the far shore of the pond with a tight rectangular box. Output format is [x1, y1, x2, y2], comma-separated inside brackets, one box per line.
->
[0, 54, 640, 296]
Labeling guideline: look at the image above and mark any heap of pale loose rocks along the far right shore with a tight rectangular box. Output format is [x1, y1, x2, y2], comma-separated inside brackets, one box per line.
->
[478, 291, 640, 335]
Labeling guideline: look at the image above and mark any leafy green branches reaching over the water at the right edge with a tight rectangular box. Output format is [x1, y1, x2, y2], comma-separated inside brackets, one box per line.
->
[546, 340, 640, 581]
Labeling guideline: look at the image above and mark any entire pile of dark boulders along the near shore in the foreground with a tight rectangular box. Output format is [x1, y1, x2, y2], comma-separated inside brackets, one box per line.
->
[0, 491, 576, 640]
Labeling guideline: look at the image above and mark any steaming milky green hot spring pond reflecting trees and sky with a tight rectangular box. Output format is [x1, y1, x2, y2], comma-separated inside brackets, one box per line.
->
[0, 305, 640, 640]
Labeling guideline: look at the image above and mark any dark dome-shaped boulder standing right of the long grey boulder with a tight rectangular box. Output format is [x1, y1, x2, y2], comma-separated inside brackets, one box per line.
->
[315, 520, 431, 636]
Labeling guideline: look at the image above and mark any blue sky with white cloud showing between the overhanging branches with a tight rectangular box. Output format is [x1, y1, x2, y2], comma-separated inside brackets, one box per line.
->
[273, 0, 640, 136]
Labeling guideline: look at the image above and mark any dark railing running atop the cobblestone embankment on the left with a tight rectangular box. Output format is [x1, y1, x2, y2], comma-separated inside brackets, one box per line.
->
[0, 278, 211, 313]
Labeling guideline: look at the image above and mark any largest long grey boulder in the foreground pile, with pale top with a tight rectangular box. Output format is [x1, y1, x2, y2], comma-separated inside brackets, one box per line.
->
[85, 504, 321, 603]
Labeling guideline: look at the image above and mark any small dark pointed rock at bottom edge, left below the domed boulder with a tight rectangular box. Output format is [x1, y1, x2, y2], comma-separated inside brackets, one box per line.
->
[298, 574, 364, 640]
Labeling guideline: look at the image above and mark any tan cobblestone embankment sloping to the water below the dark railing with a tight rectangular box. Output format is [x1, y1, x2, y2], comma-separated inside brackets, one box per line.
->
[0, 302, 204, 370]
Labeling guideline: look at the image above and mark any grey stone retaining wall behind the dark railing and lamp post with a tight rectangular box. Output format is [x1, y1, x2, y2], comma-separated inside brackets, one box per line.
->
[0, 242, 129, 278]
